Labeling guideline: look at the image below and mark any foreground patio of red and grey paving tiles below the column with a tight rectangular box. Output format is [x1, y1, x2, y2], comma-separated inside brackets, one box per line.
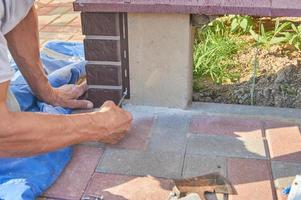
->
[37, 106, 301, 200]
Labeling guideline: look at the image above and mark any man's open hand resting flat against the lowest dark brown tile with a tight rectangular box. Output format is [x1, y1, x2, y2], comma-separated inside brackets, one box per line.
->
[43, 82, 93, 109]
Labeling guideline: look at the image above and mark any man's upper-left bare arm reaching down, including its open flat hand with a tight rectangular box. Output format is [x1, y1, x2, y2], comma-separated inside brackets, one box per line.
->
[5, 7, 93, 108]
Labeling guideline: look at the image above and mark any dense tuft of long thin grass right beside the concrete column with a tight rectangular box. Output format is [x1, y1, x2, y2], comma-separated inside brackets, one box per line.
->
[194, 26, 241, 84]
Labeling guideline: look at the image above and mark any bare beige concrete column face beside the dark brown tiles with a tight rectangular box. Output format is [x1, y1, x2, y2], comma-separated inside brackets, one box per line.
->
[128, 13, 193, 108]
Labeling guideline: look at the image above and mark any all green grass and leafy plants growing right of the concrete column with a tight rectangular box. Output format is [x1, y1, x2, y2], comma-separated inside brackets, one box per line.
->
[193, 15, 301, 90]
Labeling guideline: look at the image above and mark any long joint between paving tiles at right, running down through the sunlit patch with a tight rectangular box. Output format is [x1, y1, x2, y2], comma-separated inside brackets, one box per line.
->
[261, 121, 278, 200]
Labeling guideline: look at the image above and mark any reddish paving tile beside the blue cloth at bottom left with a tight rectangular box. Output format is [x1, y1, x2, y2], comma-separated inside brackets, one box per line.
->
[44, 146, 103, 199]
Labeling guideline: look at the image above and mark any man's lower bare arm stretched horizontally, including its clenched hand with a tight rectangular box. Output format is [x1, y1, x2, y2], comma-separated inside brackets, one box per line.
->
[0, 82, 132, 157]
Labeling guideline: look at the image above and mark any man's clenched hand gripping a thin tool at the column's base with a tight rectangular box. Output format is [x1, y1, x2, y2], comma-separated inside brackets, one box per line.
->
[89, 101, 133, 144]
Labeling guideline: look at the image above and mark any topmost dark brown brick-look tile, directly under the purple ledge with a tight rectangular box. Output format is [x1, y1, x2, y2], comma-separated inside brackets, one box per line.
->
[81, 13, 120, 36]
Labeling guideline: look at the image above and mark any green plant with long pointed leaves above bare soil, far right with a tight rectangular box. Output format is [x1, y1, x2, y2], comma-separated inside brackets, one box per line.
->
[250, 19, 291, 48]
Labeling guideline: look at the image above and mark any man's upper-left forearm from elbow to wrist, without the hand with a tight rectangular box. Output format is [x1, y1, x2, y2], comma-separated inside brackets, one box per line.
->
[5, 7, 52, 101]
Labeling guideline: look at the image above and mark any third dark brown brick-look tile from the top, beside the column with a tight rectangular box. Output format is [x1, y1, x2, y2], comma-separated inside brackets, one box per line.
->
[86, 64, 122, 86]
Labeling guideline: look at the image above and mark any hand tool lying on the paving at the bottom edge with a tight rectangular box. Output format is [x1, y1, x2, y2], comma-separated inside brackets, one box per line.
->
[172, 173, 236, 200]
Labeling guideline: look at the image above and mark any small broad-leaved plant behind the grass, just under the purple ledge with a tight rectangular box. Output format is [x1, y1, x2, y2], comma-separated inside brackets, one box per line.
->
[230, 15, 254, 35]
